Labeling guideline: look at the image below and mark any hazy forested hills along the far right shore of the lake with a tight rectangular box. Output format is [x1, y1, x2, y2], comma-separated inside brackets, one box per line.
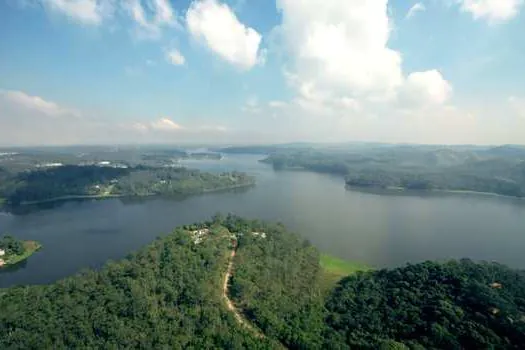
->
[263, 146, 525, 197]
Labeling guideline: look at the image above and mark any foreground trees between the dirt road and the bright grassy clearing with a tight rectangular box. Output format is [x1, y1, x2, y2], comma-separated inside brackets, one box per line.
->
[227, 217, 323, 349]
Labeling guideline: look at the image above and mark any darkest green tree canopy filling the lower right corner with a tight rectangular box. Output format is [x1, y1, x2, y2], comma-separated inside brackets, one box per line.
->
[326, 260, 525, 349]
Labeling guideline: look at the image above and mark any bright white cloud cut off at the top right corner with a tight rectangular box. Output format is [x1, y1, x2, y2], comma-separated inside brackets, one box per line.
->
[457, 0, 523, 23]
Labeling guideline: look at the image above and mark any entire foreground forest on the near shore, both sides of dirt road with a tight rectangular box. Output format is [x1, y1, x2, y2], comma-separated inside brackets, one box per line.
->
[0, 215, 525, 349]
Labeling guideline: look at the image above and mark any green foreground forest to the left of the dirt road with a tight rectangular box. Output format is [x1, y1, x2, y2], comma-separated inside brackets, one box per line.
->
[0, 229, 271, 349]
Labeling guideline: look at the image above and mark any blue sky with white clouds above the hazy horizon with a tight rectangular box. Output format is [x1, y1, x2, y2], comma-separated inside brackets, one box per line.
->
[0, 0, 525, 146]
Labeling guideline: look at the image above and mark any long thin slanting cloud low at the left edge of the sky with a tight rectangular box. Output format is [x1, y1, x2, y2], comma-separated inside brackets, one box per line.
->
[0, 90, 80, 117]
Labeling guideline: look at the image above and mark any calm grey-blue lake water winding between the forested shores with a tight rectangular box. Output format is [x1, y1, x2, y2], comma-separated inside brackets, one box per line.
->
[0, 156, 525, 287]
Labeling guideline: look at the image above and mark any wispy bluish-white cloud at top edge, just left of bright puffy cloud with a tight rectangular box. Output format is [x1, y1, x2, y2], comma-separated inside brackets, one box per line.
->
[124, 0, 177, 39]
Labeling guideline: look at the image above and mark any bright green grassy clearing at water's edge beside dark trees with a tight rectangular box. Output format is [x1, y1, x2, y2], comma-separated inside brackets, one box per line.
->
[320, 254, 372, 291]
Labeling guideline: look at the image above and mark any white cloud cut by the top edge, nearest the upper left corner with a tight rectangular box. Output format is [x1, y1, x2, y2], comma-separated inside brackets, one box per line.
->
[41, 0, 114, 25]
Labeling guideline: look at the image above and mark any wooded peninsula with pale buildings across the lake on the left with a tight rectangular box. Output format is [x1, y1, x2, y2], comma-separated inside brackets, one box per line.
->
[0, 165, 255, 206]
